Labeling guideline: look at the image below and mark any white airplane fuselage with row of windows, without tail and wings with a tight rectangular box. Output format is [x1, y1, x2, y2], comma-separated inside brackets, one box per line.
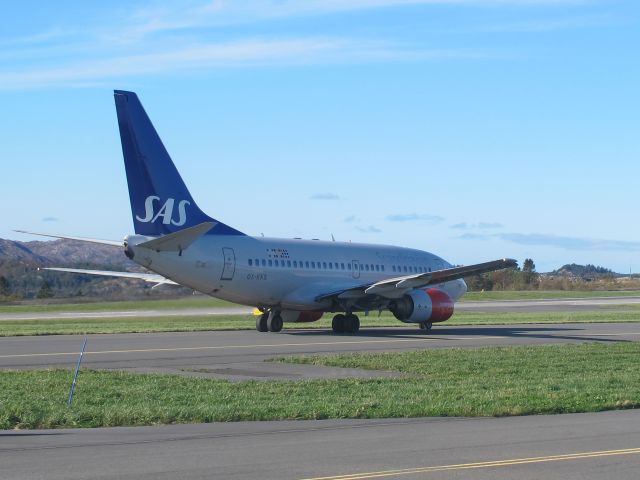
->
[125, 235, 467, 311]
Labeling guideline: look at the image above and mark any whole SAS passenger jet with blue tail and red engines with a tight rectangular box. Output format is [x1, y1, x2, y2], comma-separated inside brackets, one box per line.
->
[20, 90, 517, 333]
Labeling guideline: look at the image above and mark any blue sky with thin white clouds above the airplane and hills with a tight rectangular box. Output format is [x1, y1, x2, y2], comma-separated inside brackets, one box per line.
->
[0, 0, 640, 272]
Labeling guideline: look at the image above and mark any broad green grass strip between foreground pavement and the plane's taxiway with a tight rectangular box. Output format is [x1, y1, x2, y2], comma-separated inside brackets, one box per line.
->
[0, 343, 640, 429]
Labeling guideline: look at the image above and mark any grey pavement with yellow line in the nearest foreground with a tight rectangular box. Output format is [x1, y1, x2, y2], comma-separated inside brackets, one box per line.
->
[0, 410, 640, 480]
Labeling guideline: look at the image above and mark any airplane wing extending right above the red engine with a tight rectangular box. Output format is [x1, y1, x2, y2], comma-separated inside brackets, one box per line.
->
[316, 258, 518, 301]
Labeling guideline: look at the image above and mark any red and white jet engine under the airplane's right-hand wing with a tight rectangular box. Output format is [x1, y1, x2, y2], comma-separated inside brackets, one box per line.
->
[389, 288, 453, 323]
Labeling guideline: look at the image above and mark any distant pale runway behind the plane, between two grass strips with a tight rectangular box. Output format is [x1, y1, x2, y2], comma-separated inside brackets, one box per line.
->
[0, 297, 640, 321]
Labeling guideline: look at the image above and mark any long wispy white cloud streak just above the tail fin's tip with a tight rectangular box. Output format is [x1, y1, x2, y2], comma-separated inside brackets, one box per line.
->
[0, 37, 485, 90]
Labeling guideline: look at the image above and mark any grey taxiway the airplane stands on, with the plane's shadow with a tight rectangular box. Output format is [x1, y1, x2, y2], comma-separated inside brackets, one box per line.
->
[0, 323, 640, 379]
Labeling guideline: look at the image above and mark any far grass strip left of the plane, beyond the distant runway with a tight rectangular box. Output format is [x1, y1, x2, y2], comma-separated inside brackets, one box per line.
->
[0, 295, 240, 313]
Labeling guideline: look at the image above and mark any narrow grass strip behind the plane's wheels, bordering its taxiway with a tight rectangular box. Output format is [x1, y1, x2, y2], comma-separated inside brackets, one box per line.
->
[0, 305, 640, 337]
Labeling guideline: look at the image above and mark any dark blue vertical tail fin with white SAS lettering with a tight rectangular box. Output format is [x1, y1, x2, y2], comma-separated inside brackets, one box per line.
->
[114, 90, 244, 235]
